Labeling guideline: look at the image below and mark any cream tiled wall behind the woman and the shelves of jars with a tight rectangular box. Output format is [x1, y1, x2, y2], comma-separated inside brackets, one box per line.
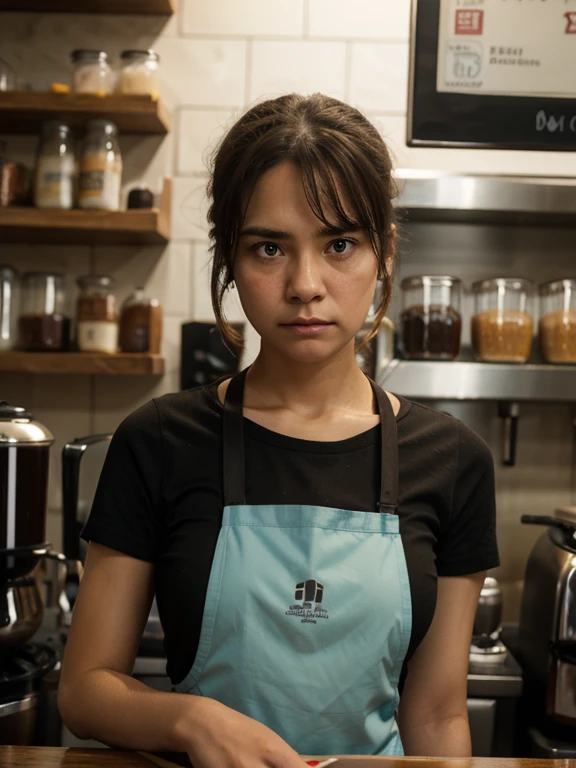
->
[0, 0, 576, 618]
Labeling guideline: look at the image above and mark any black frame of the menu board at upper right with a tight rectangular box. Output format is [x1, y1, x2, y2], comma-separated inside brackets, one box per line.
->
[408, 0, 576, 152]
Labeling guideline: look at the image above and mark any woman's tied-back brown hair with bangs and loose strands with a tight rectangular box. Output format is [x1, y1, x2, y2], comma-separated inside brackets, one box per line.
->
[207, 93, 397, 347]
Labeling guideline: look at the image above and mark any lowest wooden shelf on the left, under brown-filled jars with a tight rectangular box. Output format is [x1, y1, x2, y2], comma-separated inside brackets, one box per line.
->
[0, 352, 164, 376]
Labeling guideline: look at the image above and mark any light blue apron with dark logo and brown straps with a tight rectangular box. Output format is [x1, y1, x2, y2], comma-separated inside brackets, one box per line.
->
[175, 370, 412, 755]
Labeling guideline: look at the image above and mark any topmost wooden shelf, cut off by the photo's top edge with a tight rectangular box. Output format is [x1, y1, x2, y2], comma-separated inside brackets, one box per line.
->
[0, 0, 176, 16]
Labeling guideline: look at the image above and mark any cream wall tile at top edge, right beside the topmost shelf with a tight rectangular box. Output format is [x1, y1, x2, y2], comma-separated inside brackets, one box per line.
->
[182, 0, 304, 37]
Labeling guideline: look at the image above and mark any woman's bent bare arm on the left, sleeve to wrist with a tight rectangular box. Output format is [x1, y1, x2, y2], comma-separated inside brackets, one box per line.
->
[58, 543, 202, 750]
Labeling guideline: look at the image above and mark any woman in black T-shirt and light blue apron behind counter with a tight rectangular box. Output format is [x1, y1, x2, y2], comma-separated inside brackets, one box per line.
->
[59, 94, 498, 768]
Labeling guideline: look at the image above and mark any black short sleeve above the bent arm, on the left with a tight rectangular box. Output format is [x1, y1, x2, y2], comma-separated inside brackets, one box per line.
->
[81, 401, 162, 562]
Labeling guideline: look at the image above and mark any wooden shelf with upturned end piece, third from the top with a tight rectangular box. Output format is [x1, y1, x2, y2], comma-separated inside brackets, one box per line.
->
[0, 179, 171, 245]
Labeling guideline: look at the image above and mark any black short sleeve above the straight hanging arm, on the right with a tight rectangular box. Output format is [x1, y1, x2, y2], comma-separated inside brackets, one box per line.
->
[436, 421, 500, 576]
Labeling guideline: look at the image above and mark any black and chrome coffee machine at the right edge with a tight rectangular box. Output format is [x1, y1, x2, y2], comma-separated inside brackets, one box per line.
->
[518, 507, 576, 758]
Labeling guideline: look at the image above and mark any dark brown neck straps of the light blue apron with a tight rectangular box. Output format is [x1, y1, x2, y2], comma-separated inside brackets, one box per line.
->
[222, 368, 398, 515]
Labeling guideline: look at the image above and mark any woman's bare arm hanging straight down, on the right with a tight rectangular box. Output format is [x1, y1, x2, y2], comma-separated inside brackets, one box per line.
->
[398, 571, 486, 757]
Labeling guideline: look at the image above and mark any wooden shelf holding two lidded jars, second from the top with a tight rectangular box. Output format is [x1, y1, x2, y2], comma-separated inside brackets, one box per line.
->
[0, 92, 170, 135]
